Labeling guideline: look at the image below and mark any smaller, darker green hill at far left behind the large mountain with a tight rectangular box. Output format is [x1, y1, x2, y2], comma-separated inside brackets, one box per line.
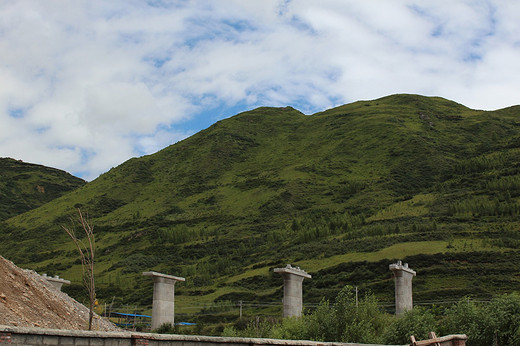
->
[0, 158, 85, 221]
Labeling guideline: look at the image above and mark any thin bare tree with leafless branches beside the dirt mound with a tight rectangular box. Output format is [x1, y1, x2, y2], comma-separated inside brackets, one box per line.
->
[62, 208, 96, 330]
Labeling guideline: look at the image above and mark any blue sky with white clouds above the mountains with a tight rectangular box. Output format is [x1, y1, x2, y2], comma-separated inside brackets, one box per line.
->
[0, 0, 520, 180]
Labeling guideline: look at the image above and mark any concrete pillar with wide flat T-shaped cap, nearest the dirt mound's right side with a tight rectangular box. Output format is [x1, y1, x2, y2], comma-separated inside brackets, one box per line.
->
[143, 272, 186, 329]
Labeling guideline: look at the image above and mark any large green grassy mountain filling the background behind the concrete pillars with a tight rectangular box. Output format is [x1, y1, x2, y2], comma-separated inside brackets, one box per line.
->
[0, 95, 520, 328]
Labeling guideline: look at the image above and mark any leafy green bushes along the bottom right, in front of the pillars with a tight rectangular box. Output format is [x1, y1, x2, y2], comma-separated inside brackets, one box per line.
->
[222, 286, 520, 346]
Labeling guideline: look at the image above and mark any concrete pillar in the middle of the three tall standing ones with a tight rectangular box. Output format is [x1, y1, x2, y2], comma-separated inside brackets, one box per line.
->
[274, 264, 311, 317]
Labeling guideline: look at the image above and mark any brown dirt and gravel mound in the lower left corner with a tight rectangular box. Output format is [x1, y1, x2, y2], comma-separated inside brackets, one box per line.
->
[0, 256, 119, 331]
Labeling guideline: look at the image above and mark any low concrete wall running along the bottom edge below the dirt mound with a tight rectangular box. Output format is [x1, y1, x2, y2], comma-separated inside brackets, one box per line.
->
[0, 326, 403, 346]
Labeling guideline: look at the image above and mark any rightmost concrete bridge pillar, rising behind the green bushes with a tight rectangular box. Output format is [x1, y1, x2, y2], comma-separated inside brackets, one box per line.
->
[390, 261, 416, 316]
